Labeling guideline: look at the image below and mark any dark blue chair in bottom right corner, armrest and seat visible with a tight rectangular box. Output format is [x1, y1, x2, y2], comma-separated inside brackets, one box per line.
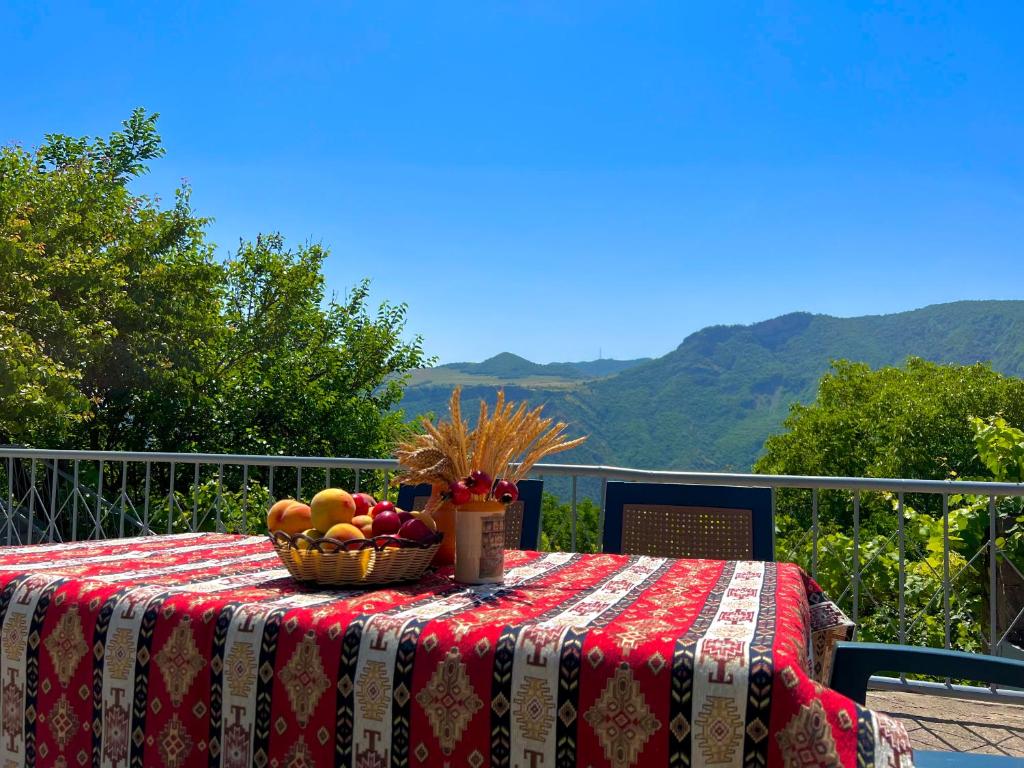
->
[829, 642, 1024, 768]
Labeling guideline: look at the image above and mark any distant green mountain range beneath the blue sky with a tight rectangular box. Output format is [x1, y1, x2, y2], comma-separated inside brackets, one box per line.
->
[401, 301, 1024, 471]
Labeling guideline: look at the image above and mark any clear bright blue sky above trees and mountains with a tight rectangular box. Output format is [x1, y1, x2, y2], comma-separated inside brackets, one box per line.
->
[0, 0, 1024, 361]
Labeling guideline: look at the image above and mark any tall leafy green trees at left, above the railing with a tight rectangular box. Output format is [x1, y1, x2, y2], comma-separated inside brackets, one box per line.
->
[0, 110, 428, 456]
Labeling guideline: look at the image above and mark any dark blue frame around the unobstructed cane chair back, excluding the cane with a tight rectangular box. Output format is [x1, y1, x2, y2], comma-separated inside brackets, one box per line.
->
[602, 480, 775, 560]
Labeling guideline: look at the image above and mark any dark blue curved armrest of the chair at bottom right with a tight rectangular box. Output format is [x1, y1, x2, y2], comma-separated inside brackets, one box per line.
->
[829, 642, 1024, 703]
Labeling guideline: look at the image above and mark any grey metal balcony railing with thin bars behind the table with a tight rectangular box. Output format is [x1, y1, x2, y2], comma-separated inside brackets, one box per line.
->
[0, 447, 1024, 697]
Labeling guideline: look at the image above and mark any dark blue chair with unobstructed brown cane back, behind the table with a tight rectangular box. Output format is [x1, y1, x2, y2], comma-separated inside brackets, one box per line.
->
[603, 481, 775, 560]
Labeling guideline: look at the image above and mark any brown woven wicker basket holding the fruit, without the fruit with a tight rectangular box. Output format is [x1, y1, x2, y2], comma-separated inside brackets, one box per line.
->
[270, 530, 443, 587]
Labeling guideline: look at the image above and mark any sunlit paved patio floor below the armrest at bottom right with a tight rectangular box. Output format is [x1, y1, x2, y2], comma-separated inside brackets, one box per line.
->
[867, 691, 1024, 758]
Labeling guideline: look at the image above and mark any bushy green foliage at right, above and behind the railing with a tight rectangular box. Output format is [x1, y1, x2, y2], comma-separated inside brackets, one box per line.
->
[756, 358, 1024, 650]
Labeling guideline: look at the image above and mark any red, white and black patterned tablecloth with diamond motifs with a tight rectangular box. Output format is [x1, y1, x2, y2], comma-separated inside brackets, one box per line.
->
[0, 534, 910, 768]
